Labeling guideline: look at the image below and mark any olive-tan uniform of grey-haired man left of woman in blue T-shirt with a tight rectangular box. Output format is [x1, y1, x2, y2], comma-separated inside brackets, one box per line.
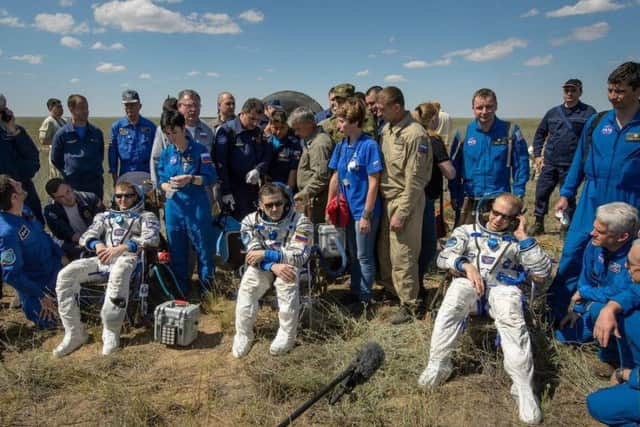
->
[296, 128, 333, 224]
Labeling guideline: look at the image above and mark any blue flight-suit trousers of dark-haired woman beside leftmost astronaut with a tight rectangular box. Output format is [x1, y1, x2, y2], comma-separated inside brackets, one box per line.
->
[164, 196, 215, 295]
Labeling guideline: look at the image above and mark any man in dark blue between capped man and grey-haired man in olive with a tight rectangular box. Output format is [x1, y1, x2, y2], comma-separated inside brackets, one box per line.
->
[267, 110, 302, 193]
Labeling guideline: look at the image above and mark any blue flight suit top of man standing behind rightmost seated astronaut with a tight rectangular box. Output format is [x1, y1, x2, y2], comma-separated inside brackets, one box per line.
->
[449, 117, 529, 199]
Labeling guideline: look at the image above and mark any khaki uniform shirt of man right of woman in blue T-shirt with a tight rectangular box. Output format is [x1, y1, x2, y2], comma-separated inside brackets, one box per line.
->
[380, 112, 433, 218]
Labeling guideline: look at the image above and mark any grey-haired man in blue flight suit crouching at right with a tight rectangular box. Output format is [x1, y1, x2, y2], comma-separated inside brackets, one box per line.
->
[555, 202, 639, 364]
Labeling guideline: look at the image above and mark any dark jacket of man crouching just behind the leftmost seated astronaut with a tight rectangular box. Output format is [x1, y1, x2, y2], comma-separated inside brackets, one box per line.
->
[44, 191, 104, 243]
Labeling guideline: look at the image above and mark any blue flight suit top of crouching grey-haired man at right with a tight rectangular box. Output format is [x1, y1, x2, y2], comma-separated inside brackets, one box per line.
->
[578, 240, 632, 304]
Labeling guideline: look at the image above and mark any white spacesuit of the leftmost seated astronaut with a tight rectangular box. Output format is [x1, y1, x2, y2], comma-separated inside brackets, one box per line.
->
[53, 191, 160, 357]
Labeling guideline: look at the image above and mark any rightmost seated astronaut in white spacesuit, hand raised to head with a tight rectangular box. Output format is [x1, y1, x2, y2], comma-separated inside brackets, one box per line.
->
[418, 193, 551, 424]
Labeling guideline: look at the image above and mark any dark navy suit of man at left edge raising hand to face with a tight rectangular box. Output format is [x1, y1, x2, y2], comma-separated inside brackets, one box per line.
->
[0, 125, 44, 224]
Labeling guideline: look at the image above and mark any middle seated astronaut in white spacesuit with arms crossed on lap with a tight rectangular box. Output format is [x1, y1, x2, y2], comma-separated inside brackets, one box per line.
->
[232, 184, 313, 358]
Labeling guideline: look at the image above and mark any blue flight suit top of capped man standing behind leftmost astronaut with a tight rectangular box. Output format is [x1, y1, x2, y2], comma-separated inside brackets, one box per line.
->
[109, 116, 156, 176]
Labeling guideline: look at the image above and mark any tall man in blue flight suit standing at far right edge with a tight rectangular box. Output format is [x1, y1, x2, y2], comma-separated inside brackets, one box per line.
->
[548, 62, 640, 320]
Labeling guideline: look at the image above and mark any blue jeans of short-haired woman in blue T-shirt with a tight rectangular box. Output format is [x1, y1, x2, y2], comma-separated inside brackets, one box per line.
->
[346, 217, 380, 303]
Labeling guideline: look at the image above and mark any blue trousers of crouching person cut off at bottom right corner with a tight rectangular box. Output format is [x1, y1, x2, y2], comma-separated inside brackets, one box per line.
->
[587, 311, 640, 427]
